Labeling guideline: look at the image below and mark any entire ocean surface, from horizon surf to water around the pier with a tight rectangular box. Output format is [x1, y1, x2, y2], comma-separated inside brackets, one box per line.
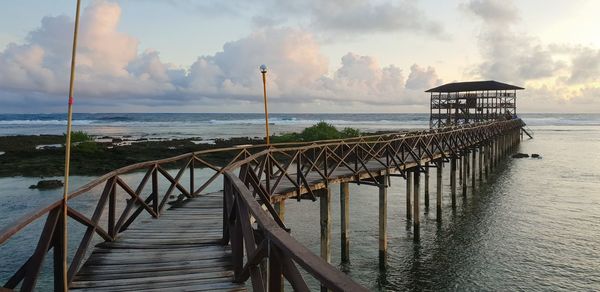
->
[0, 114, 600, 291]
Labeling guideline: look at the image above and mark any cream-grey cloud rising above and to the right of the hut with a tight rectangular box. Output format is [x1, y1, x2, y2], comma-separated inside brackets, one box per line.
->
[461, 0, 600, 111]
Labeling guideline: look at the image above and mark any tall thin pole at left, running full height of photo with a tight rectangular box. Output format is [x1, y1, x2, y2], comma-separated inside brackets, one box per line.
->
[62, 0, 81, 291]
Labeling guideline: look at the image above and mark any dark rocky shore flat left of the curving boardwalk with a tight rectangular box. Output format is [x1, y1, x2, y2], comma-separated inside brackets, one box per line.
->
[0, 135, 264, 177]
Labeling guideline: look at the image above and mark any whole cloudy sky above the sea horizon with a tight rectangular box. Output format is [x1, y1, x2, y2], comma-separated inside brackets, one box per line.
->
[0, 0, 600, 113]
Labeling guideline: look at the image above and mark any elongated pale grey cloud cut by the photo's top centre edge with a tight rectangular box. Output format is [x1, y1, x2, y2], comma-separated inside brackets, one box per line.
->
[172, 0, 444, 36]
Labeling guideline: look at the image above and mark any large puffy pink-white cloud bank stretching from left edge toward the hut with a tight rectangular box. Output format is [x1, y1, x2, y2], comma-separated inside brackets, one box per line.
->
[0, 1, 440, 110]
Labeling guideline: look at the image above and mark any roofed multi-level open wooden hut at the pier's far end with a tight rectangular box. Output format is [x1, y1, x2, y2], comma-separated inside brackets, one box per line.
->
[425, 80, 524, 128]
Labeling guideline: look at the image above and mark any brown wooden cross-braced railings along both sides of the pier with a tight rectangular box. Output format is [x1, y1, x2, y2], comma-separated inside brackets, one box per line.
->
[0, 119, 523, 291]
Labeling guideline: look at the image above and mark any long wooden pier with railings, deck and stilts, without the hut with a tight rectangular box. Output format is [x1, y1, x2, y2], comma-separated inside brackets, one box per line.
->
[0, 119, 524, 291]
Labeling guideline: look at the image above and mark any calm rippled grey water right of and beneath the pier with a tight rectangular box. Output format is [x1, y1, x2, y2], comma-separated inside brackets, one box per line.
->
[286, 127, 600, 291]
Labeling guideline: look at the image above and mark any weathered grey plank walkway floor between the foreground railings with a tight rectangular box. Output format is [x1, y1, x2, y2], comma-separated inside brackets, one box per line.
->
[71, 192, 246, 291]
